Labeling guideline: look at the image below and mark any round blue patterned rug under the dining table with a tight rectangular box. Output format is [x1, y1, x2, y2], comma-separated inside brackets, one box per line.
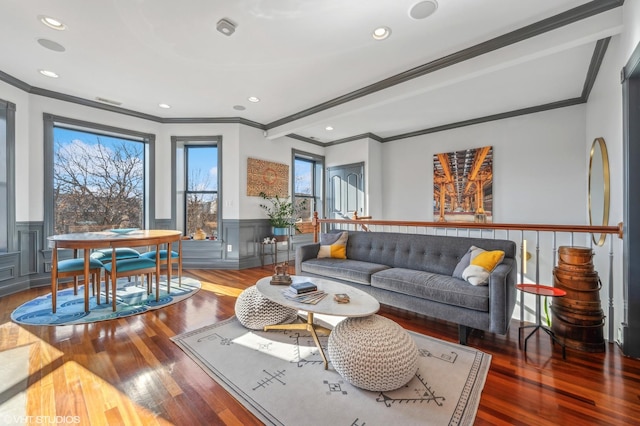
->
[11, 277, 200, 325]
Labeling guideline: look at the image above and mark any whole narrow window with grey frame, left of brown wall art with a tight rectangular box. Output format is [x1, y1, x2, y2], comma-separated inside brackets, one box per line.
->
[171, 136, 222, 239]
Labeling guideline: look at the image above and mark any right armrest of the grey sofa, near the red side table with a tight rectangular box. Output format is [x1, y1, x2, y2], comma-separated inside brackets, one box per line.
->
[489, 259, 517, 334]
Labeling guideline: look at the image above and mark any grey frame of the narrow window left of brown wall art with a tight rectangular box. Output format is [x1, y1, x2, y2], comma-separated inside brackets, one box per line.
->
[171, 136, 223, 236]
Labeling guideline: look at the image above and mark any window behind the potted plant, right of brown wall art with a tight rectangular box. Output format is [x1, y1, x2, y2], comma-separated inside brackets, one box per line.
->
[293, 150, 324, 232]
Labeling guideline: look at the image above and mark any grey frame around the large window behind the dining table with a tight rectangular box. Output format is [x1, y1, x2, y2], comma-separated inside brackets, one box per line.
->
[43, 113, 156, 236]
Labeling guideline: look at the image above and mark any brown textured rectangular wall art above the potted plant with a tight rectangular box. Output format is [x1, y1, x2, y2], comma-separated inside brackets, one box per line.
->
[247, 158, 289, 198]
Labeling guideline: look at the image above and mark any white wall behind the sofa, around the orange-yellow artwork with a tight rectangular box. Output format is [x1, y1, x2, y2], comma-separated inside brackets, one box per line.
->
[382, 106, 587, 225]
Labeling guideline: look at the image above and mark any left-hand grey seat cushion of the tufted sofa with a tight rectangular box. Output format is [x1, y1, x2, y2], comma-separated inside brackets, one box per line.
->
[297, 258, 389, 284]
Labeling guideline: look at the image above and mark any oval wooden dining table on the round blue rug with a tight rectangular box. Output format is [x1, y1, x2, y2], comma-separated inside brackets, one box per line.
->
[47, 229, 182, 313]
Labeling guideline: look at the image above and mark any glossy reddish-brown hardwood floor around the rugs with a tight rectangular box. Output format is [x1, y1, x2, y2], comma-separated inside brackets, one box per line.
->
[0, 268, 640, 426]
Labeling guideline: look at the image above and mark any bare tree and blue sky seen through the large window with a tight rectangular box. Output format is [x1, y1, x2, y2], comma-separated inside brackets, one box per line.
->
[53, 127, 144, 234]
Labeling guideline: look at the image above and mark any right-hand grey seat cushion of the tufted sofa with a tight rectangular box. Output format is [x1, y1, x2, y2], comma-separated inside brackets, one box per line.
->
[371, 268, 489, 315]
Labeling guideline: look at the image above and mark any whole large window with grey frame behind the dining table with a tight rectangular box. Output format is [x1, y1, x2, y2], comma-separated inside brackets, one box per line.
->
[45, 117, 153, 238]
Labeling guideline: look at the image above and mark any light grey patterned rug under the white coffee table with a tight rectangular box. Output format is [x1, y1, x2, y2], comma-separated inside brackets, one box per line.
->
[172, 317, 491, 426]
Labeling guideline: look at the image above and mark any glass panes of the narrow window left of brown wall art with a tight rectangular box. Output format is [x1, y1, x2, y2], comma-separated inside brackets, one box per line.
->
[184, 145, 218, 237]
